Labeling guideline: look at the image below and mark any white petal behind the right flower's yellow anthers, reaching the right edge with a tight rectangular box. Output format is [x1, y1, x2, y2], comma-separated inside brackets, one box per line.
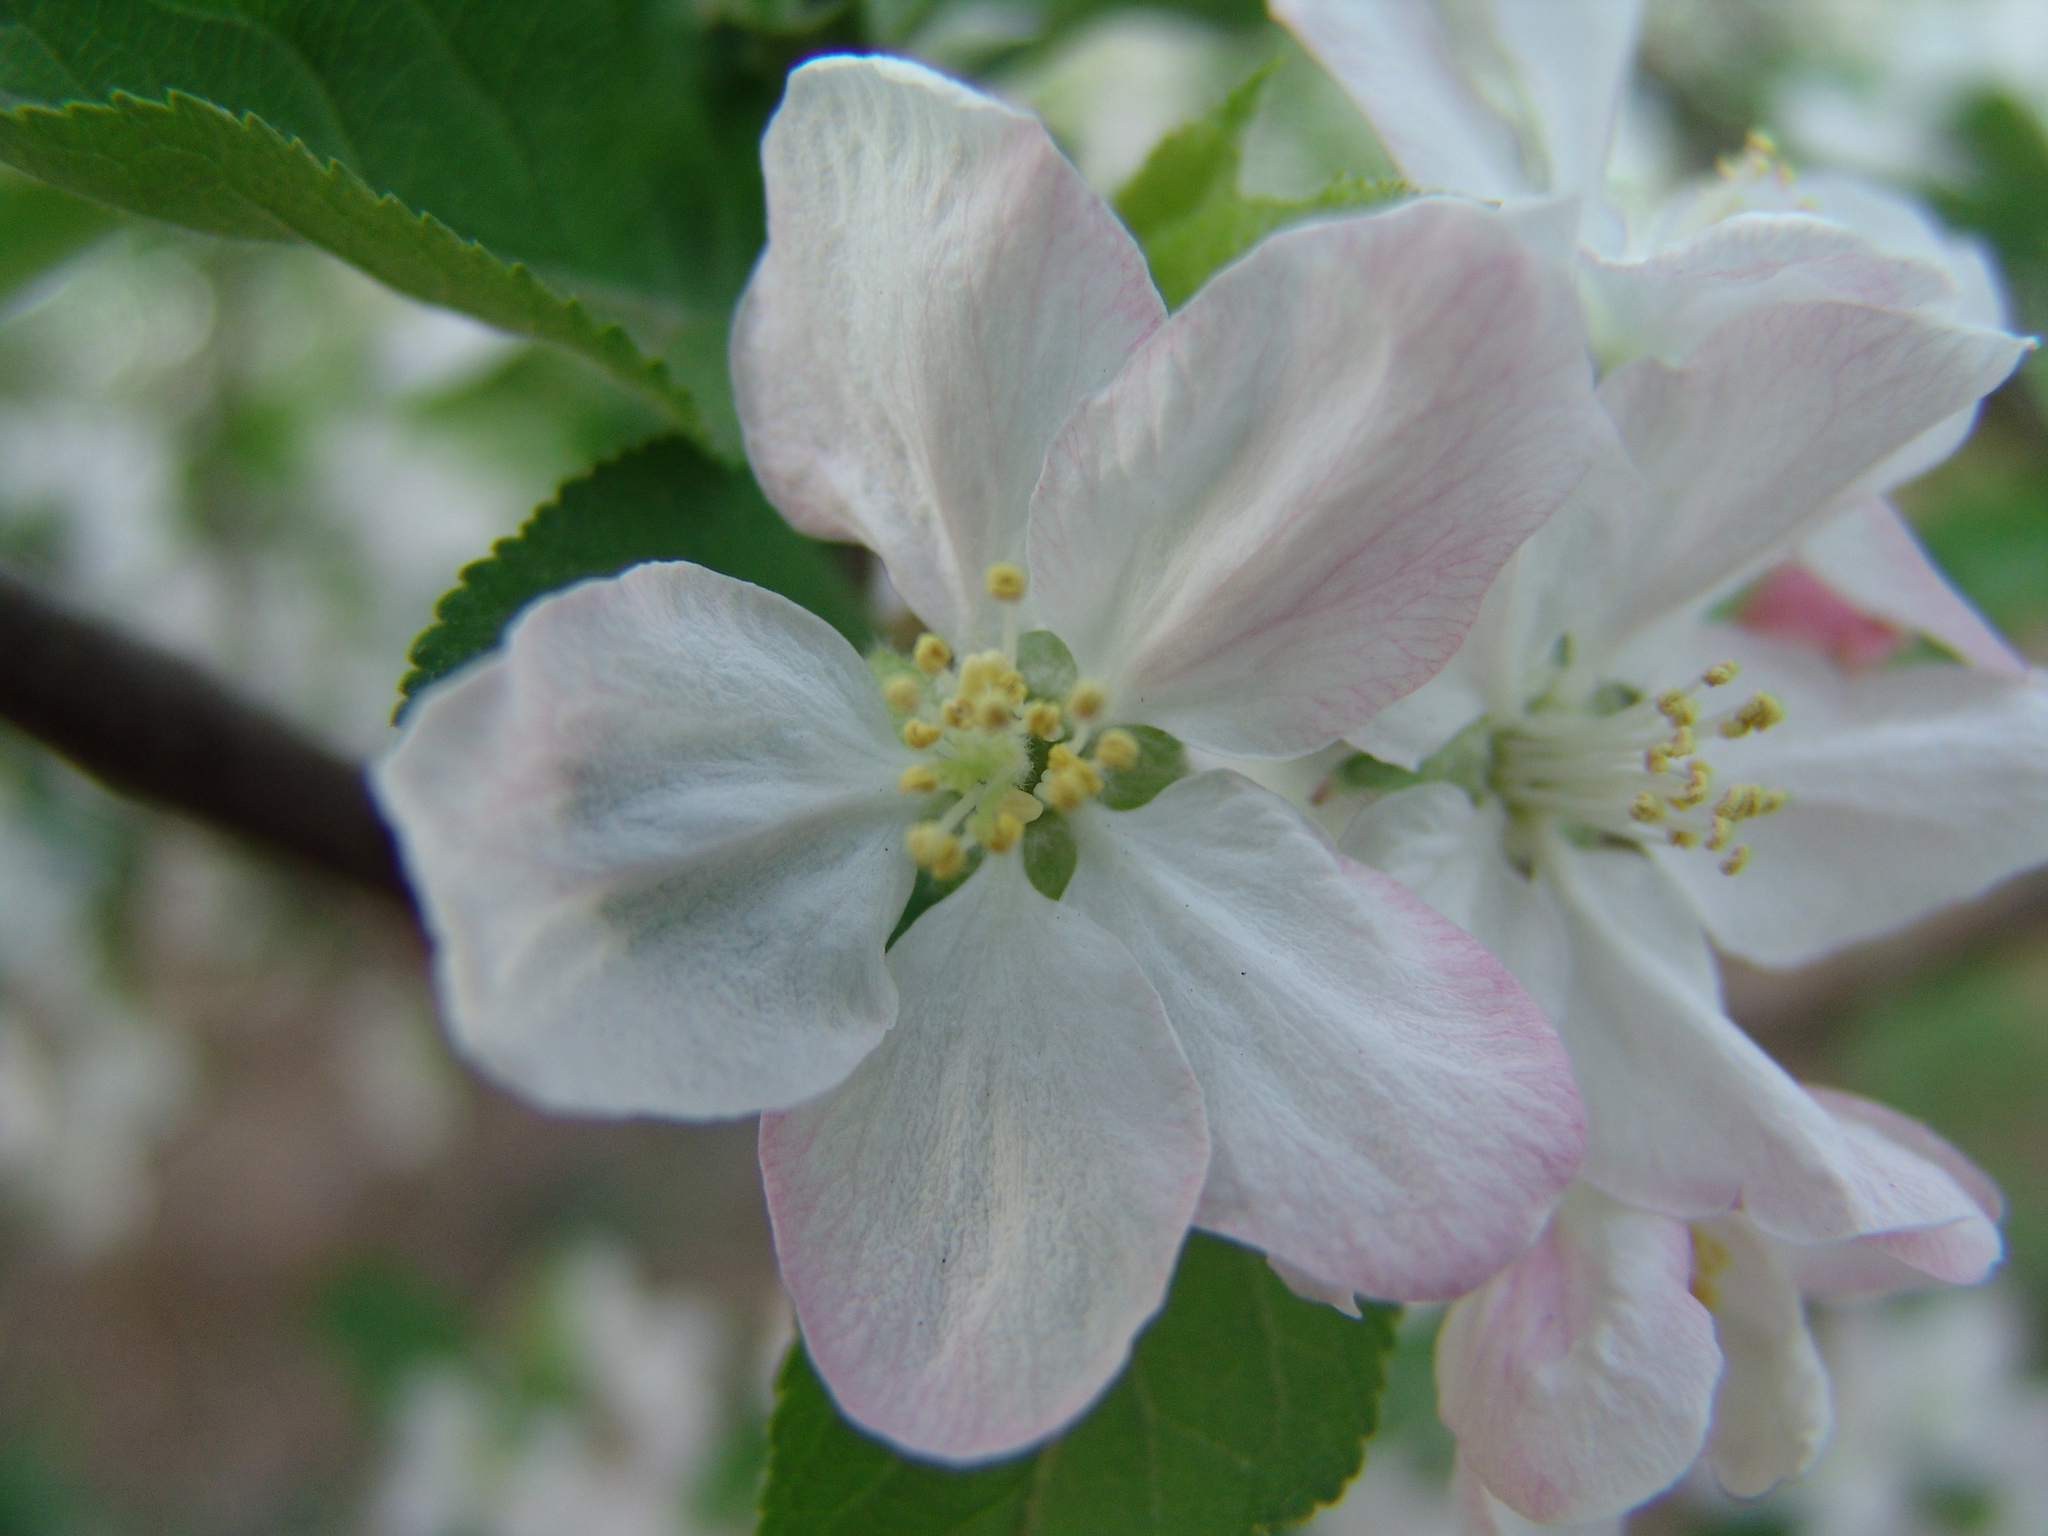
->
[1655, 625, 2048, 965]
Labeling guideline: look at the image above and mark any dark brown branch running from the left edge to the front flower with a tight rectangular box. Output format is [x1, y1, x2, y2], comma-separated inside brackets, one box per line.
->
[0, 571, 412, 921]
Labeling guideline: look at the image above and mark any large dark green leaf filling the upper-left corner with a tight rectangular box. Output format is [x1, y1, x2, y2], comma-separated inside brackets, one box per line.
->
[0, 0, 782, 438]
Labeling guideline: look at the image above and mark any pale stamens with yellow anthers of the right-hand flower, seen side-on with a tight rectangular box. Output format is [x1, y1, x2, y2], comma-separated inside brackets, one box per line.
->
[1489, 662, 1786, 874]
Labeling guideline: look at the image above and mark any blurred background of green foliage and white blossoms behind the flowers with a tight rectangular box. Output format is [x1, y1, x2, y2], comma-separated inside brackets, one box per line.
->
[0, 0, 2048, 1536]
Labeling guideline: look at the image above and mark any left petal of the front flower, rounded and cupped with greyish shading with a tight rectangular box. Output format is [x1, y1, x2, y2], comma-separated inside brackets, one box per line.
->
[377, 563, 913, 1116]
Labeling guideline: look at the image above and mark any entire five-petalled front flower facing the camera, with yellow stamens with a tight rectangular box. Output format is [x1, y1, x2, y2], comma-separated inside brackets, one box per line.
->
[381, 59, 1597, 1460]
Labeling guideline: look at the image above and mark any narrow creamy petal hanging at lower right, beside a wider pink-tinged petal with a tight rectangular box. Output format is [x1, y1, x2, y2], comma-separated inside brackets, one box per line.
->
[1698, 1217, 1835, 1499]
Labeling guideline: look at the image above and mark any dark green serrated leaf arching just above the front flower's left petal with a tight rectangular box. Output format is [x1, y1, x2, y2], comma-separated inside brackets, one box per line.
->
[399, 436, 872, 709]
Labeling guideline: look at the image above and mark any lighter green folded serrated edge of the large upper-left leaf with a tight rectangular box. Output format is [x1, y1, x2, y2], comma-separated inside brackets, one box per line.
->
[0, 90, 707, 442]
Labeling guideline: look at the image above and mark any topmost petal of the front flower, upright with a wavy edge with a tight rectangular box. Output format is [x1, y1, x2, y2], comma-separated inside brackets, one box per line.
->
[733, 57, 1165, 643]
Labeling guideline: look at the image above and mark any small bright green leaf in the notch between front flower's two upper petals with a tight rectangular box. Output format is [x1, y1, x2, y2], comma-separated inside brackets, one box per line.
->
[1116, 61, 1411, 309]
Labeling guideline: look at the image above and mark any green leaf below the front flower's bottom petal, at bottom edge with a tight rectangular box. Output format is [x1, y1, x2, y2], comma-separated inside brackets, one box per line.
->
[760, 1233, 1399, 1536]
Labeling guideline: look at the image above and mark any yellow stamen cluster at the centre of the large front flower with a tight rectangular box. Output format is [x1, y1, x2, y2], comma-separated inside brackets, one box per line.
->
[877, 563, 1139, 881]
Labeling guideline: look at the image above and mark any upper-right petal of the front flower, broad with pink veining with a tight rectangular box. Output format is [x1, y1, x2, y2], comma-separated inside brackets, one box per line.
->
[1028, 201, 1606, 758]
